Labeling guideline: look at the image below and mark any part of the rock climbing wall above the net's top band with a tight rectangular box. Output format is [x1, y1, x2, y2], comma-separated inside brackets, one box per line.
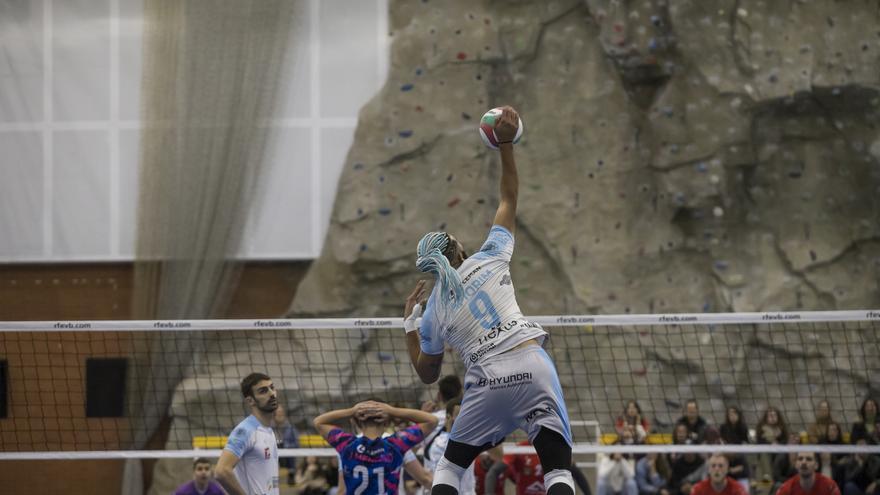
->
[291, 1, 880, 322]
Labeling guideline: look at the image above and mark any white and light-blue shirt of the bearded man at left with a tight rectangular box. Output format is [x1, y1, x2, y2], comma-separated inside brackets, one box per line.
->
[224, 415, 278, 495]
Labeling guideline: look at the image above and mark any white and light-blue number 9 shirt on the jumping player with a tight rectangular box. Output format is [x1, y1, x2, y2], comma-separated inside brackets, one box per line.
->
[419, 225, 547, 367]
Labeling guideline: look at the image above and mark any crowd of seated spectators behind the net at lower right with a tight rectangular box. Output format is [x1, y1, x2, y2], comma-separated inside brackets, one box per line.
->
[596, 398, 880, 495]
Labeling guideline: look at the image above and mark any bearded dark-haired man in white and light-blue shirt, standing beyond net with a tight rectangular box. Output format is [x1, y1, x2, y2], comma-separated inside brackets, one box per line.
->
[214, 373, 278, 495]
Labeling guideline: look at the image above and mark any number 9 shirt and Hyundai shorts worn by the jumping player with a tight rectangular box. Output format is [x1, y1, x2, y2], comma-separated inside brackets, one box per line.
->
[419, 225, 571, 452]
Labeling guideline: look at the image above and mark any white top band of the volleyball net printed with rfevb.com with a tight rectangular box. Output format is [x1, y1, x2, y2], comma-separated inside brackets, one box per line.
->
[0, 309, 880, 332]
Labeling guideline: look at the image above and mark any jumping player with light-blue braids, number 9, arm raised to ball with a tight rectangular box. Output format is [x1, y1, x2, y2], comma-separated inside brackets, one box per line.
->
[404, 107, 574, 495]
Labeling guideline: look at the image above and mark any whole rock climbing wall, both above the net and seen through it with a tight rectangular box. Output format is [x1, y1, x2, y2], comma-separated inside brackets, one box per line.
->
[153, 0, 880, 490]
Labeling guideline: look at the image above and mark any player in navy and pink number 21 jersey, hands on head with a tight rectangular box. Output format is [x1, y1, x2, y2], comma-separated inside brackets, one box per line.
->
[314, 400, 437, 495]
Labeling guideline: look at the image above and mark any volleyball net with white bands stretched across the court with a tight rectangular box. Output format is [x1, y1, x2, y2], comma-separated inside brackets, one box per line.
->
[0, 310, 880, 459]
